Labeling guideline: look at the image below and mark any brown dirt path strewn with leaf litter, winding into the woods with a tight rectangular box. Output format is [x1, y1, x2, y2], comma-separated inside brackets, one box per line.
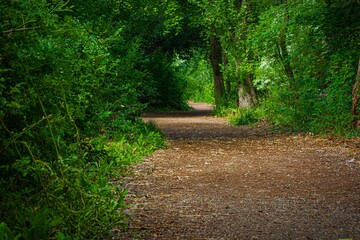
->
[116, 104, 360, 240]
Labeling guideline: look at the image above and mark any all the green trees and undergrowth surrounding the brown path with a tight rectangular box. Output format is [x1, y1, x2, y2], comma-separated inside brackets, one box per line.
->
[0, 0, 360, 240]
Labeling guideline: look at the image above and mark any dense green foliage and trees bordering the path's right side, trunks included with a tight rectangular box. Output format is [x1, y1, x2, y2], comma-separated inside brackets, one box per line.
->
[187, 0, 360, 135]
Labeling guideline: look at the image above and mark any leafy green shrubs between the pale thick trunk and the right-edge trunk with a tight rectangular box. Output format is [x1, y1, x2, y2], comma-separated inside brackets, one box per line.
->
[250, 1, 359, 136]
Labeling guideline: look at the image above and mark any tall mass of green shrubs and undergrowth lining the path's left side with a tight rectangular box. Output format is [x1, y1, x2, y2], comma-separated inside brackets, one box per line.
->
[0, 0, 164, 239]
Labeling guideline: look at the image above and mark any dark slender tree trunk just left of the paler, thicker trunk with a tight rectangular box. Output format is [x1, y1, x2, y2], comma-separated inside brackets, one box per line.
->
[210, 27, 225, 107]
